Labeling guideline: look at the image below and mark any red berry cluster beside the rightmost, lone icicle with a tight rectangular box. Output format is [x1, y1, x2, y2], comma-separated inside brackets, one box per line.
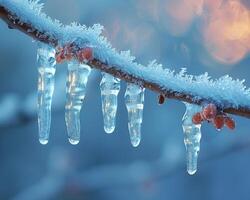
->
[192, 103, 235, 130]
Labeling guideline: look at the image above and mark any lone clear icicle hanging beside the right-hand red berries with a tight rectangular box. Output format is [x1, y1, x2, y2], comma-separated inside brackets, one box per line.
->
[182, 103, 201, 175]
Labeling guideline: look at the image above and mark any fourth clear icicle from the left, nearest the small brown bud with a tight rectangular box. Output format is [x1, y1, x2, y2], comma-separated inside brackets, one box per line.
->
[125, 83, 145, 147]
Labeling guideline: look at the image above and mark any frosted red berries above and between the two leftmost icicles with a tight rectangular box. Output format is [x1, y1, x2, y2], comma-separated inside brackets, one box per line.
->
[56, 43, 93, 63]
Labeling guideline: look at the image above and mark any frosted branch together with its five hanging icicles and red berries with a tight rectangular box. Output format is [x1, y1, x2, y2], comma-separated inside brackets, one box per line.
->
[0, 0, 250, 175]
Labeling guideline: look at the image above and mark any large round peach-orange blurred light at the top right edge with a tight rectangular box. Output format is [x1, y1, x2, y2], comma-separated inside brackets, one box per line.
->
[203, 1, 250, 64]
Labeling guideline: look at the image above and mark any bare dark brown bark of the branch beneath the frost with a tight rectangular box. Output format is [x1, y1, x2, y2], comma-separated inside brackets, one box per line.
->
[0, 3, 250, 118]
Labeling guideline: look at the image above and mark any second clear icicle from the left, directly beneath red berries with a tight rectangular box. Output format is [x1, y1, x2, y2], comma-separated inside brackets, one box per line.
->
[65, 61, 91, 145]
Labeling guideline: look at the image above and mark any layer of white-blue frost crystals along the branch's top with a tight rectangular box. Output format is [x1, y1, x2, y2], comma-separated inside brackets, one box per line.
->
[0, 0, 250, 108]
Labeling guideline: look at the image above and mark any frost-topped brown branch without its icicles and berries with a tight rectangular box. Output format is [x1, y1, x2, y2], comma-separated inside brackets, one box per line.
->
[0, 0, 250, 118]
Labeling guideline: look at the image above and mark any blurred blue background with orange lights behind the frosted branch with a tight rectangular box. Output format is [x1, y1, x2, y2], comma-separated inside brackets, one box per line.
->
[0, 0, 250, 200]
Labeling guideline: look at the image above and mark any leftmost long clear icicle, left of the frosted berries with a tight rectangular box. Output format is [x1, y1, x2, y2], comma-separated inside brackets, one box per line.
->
[37, 43, 56, 144]
